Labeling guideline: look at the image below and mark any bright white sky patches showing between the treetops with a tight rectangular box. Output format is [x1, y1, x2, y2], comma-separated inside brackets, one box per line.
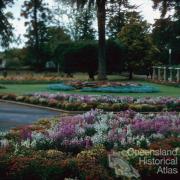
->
[9, 0, 160, 47]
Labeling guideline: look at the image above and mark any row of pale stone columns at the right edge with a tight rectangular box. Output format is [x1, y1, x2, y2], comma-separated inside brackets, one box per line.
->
[152, 66, 180, 83]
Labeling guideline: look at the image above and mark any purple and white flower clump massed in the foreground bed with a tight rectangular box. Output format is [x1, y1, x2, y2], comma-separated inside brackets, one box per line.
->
[44, 110, 180, 147]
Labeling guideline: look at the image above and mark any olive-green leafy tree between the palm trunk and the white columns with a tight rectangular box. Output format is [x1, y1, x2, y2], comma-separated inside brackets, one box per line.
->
[118, 13, 158, 79]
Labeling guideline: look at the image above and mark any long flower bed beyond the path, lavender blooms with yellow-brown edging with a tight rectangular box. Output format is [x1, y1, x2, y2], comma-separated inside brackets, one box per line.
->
[0, 93, 180, 112]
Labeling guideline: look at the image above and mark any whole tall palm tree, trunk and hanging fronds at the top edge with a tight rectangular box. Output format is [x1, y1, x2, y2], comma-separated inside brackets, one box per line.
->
[59, 0, 128, 80]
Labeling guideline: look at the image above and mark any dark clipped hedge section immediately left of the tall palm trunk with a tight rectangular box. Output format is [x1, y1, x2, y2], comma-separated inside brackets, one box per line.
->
[55, 42, 97, 77]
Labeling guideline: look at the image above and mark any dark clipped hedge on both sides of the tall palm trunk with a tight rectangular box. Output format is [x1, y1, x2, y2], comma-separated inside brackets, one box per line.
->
[55, 41, 124, 79]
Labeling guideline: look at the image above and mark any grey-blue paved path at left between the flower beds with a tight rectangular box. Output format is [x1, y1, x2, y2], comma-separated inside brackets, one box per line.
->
[0, 102, 59, 131]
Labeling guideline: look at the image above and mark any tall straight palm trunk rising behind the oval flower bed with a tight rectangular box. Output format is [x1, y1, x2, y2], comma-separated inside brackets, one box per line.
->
[97, 0, 107, 80]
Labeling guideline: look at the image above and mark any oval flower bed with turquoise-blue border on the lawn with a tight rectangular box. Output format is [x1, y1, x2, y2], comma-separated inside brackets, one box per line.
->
[48, 81, 159, 93]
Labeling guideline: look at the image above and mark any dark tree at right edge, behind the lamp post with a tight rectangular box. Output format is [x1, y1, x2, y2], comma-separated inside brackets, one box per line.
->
[153, 0, 180, 63]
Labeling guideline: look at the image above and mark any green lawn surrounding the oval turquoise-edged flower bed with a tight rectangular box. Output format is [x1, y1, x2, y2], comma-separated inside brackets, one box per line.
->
[0, 81, 180, 97]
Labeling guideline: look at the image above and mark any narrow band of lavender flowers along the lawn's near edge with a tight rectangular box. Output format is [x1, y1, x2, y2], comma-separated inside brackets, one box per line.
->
[31, 93, 180, 105]
